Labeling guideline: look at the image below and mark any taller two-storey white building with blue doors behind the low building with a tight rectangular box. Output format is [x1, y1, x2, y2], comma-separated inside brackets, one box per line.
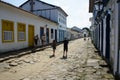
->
[20, 0, 68, 42]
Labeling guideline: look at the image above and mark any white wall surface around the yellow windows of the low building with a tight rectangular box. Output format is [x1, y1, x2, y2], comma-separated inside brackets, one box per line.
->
[0, 3, 57, 52]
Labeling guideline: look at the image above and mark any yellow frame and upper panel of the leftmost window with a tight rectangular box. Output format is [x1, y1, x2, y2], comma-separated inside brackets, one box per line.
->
[2, 20, 14, 43]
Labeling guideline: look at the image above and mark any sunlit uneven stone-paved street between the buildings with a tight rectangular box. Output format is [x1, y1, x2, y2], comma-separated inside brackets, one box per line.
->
[0, 39, 115, 80]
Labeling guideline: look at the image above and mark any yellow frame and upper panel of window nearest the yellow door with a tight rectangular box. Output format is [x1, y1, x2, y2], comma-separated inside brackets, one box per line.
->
[17, 22, 26, 42]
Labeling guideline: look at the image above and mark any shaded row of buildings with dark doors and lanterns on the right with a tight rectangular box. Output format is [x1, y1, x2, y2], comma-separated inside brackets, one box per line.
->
[89, 0, 120, 79]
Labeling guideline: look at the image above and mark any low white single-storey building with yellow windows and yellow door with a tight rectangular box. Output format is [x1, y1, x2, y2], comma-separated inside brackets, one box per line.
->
[0, 1, 58, 53]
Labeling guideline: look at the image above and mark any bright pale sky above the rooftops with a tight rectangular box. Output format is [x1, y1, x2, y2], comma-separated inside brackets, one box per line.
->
[2, 0, 92, 29]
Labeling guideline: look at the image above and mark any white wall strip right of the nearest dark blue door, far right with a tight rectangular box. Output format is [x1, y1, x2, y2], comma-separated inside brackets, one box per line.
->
[105, 0, 120, 74]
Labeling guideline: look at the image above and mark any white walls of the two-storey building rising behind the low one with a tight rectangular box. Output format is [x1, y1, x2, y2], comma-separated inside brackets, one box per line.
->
[21, 0, 67, 42]
